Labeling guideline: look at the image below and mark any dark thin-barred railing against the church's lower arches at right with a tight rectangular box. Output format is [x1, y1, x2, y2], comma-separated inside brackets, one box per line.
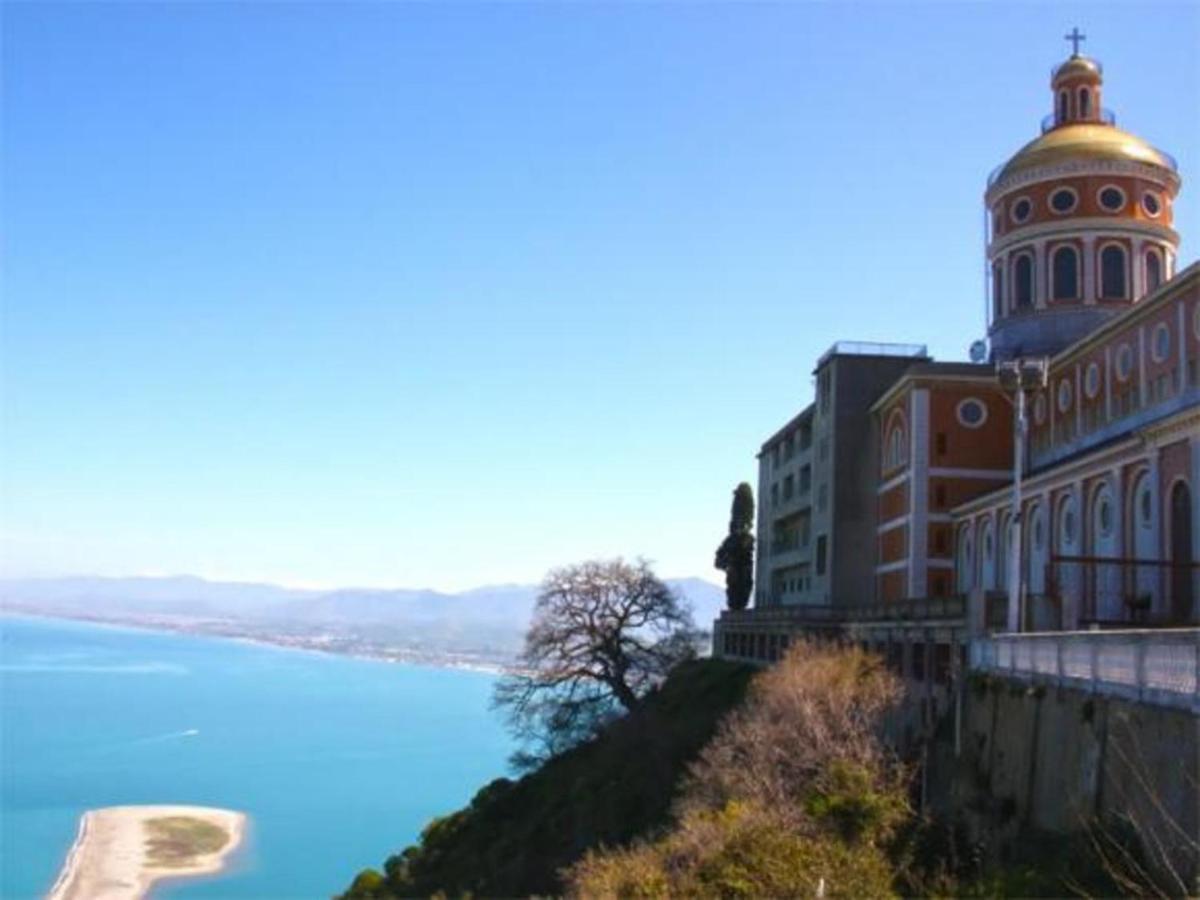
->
[1046, 554, 1200, 628]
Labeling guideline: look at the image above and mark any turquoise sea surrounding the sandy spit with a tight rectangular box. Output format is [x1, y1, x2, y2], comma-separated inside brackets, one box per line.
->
[0, 617, 512, 900]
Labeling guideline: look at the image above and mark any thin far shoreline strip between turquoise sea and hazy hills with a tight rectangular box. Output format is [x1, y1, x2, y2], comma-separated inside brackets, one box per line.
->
[0, 605, 515, 676]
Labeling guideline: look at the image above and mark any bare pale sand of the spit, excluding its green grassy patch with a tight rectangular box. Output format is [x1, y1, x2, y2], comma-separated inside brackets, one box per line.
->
[47, 805, 247, 900]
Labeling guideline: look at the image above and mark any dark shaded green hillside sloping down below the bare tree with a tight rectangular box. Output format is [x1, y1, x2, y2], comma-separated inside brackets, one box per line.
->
[343, 660, 754, 900]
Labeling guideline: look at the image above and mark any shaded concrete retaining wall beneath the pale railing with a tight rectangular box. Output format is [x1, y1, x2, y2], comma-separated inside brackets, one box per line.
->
[945, 677, 1200, 880]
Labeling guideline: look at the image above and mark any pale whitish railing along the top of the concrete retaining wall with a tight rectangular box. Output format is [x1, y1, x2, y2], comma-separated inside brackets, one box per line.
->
[971, 629, 1200, 712]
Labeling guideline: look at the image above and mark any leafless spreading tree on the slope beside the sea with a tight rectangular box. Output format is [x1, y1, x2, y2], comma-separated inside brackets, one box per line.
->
[493, 559, 698, 767]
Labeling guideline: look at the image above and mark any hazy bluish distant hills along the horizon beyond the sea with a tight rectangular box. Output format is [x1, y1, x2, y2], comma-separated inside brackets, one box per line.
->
[0, 576, 725, 656]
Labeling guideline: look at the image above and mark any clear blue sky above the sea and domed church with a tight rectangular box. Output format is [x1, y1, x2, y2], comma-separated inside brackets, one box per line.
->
[0, 2, 1200, 590]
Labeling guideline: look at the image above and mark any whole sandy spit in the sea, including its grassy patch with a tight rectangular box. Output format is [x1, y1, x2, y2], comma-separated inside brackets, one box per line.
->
[48, 805, 246, 900]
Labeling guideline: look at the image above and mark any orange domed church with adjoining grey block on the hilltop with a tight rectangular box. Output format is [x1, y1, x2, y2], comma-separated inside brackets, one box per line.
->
[714, 45, 1200, 672]
